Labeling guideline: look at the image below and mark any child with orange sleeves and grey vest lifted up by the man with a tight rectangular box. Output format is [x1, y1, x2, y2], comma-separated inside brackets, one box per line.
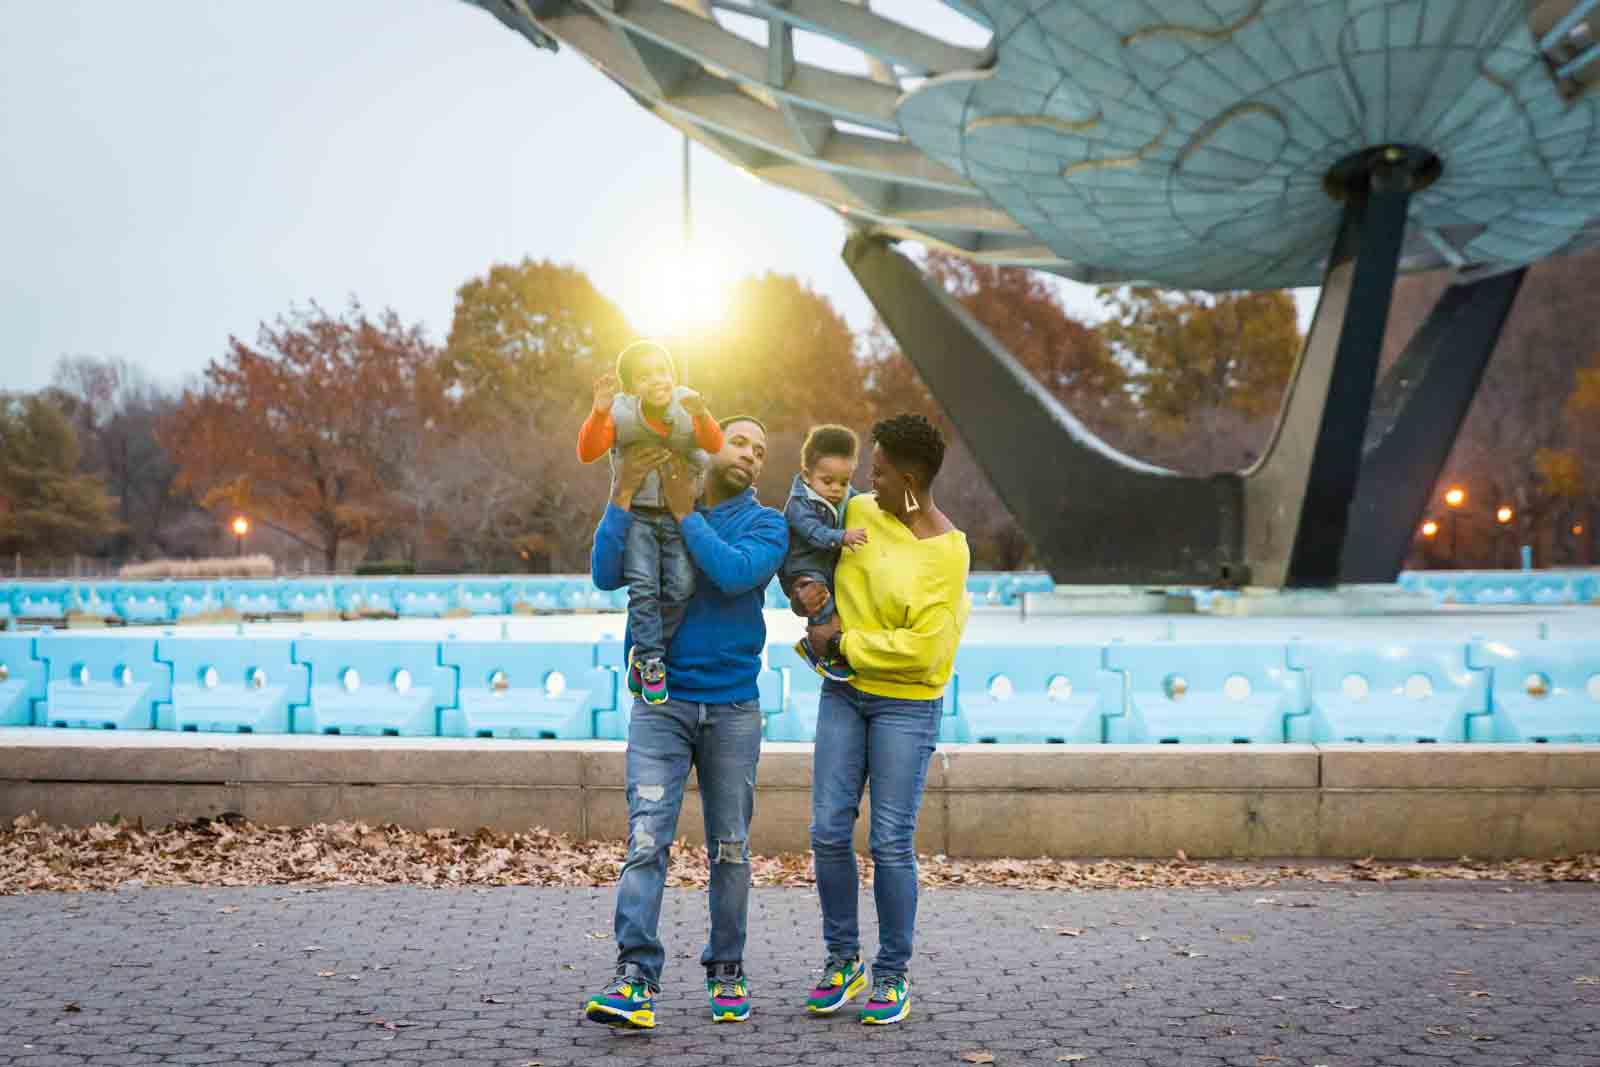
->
[578, 341, 722, 704]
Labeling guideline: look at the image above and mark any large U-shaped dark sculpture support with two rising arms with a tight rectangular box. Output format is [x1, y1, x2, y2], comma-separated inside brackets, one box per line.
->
[845, 147, 1437, 585]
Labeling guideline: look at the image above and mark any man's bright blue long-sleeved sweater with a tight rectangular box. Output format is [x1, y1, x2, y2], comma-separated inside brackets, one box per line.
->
[589, 490, 789, 704]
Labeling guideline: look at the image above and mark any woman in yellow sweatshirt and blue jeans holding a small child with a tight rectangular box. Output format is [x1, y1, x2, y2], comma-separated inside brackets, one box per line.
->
[795, 414, 971, 1024]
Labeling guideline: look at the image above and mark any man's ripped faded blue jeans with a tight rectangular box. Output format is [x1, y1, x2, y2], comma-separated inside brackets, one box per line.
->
[616, 699, 762, 985]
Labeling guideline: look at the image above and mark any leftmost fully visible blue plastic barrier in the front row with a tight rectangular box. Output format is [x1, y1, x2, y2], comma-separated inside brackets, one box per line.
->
[34, 632, 173, 729]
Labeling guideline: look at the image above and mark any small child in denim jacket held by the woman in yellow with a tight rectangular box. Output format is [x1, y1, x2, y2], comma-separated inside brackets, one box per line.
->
[778, 426, 867, 681]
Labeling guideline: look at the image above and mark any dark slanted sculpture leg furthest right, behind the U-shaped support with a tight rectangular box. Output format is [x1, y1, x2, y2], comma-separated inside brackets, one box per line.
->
[1339, 267, 1528, 582]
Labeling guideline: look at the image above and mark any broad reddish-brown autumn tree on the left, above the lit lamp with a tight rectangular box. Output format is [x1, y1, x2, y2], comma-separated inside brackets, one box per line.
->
[158, 302, 443, 571]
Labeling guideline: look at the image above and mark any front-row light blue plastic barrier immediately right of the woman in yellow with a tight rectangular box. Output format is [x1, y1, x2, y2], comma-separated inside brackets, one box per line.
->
[952, 645, 1122, 744]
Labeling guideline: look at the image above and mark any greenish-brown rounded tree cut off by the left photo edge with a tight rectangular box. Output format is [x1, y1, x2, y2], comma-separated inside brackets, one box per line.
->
[0, 394, 117, 555]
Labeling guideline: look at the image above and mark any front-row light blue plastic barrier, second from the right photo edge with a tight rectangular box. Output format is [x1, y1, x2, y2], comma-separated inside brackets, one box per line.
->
[1288, 641, 1488, 742]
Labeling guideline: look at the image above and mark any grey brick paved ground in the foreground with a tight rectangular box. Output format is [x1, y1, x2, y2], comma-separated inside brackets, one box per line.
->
[0, 883, 1600, 1067]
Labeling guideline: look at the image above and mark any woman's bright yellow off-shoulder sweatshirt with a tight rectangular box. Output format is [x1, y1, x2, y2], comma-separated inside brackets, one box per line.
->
[834, 496, 971, 701]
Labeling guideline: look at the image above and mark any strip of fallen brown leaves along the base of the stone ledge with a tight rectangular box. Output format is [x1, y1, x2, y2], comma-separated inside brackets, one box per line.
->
[0, 814, 1600, 895]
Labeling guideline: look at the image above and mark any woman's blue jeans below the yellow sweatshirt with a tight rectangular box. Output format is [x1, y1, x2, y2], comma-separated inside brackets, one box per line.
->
[811, 681, 944, 977]
